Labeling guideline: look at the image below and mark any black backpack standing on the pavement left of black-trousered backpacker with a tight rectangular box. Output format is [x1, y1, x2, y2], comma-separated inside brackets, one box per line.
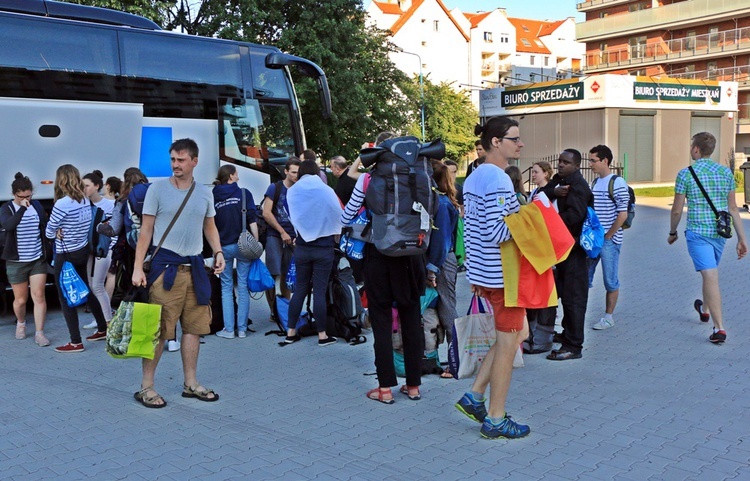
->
[326, 251, 367, 345]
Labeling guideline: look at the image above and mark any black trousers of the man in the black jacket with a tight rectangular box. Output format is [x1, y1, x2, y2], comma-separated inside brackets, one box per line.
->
[557, 248, 589, 353]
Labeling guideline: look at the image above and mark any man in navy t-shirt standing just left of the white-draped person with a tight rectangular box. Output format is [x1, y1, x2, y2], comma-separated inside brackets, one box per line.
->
[263, 157, 300, 315]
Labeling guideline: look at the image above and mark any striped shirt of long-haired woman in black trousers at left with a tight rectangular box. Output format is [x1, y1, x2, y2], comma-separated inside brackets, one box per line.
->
[45, 196, 91, 252]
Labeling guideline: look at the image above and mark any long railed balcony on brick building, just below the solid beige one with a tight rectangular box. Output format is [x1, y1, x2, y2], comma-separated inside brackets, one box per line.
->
[584, 27, 750, 74]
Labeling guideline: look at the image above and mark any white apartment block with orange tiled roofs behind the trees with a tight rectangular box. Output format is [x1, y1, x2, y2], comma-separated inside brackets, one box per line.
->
[367, 0, 585, 105]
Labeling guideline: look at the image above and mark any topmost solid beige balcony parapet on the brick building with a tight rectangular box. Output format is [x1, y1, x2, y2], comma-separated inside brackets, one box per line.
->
[576, 0, 750, 42]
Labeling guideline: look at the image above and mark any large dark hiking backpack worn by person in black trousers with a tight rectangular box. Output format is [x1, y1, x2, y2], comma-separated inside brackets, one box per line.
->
[361, 137, 445, 257]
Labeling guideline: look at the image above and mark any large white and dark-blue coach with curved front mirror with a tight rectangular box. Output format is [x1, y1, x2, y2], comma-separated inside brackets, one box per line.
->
[0, 0, 331, 202]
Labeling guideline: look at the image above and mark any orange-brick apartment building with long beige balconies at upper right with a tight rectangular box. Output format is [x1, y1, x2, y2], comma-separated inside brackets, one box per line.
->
[576, 0, 750, 155]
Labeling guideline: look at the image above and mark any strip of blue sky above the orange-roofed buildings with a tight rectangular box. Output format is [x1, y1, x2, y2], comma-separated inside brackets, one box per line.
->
[388, 0, 584, 22]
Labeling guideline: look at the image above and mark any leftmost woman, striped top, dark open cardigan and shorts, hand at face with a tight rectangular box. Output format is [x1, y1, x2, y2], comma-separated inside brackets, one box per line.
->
[0, 172, 51, 347]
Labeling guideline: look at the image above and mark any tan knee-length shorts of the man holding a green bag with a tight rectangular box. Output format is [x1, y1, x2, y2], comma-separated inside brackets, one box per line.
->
[149, 266, 211, 340]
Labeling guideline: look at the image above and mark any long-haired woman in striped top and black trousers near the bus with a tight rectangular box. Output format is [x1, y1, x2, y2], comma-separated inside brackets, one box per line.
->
[45, 164, 107, 352]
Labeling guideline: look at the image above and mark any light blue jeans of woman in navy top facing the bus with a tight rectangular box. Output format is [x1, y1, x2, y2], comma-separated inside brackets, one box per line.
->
[219, 244, 250, 332]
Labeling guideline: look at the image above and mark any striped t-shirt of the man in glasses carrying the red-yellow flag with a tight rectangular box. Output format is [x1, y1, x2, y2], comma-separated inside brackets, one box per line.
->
[464, 163, 521, 288]
